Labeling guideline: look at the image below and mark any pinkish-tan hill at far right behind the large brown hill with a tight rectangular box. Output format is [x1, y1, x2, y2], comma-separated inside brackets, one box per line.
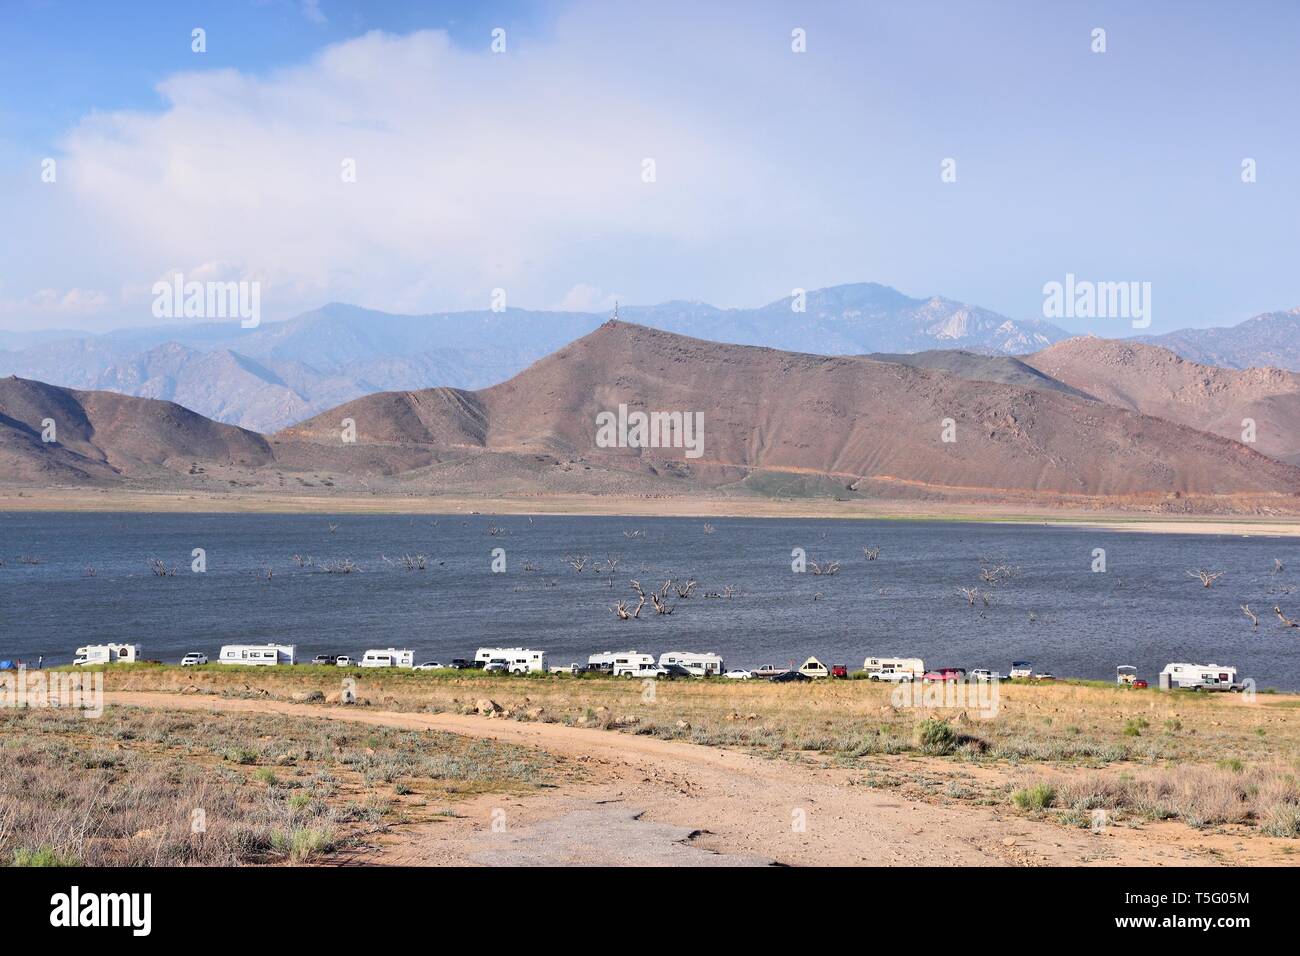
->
[1023, 338, 1300, 463]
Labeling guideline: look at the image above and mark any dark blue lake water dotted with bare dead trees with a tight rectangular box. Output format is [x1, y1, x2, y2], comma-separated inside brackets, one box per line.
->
[0, 512, 1300, 691]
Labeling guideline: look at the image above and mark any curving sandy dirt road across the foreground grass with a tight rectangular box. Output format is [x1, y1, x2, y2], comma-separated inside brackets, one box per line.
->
[98, 692, 1294, 866]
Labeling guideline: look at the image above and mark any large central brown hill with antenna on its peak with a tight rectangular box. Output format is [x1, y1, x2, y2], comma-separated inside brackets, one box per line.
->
[274, 323, 1300, 497]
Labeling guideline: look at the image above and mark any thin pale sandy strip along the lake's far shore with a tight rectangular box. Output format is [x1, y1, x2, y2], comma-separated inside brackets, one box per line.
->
[0, 488, 1300, 537]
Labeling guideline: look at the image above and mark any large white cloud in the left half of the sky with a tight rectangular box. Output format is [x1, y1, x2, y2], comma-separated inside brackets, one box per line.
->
[50, 13, 815, 327]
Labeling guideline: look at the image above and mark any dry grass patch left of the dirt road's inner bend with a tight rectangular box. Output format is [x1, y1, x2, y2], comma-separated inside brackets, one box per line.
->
[0, 708, 553, 866]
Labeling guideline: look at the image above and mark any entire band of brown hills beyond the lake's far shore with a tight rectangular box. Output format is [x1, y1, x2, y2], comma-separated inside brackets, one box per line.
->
[0, 321, 1300, 514]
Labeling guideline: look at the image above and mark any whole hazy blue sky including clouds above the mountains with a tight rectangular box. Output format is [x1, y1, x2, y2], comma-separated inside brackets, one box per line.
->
[0, 0, 1300, 334]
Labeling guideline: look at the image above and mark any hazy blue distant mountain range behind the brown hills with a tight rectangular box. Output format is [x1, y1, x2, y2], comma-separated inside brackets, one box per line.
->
[0, 282, 1300, 432]
